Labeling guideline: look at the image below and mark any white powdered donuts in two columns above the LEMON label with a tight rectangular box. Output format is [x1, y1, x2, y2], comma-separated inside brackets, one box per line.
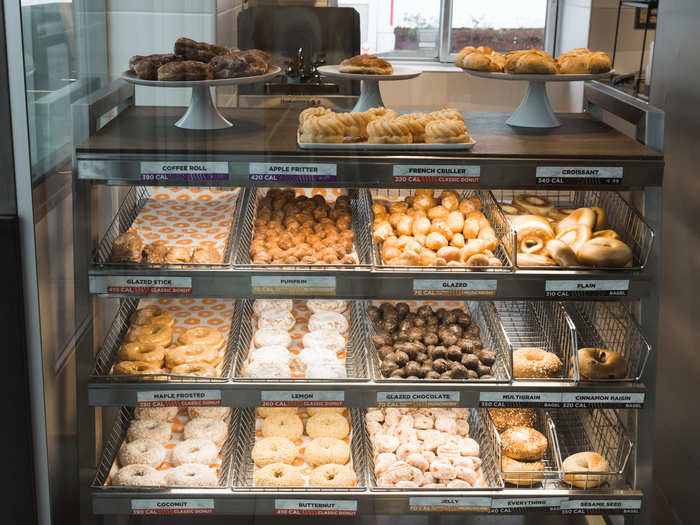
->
[243, 299, 350, 379]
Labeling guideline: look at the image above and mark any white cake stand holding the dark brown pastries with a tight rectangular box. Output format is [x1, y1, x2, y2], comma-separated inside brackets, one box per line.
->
[122, 66, 281, 129]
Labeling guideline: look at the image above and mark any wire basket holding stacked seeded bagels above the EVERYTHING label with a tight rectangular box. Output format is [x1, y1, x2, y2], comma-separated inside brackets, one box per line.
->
[489, 409, 561, 488]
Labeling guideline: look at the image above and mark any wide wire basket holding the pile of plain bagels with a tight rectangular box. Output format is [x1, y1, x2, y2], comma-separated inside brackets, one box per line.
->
[491, 190, 654, 271]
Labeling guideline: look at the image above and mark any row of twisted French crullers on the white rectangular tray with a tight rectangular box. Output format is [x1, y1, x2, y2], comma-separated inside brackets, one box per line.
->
[298, 106, 472, 144]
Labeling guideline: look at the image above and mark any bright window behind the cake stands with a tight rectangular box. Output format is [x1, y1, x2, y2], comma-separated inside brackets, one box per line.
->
[332, 0, 557, 62]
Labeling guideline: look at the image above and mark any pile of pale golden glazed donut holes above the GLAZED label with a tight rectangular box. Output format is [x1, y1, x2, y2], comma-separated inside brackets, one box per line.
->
[372, 189, 503, 266]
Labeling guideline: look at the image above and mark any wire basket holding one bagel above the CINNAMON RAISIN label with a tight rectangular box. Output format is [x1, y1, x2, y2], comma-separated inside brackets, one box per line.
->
[562, 301, 651, 382]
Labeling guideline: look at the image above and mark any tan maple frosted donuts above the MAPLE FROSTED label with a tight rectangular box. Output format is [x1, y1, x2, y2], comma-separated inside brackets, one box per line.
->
[112, 306, 226, 379]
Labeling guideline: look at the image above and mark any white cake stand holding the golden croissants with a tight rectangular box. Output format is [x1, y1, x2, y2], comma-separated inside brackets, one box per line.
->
[464, 69, 615, 128]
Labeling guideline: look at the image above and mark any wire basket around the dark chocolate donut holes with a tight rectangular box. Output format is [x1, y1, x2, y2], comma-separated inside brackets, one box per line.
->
[362, 300, 511, 385]
